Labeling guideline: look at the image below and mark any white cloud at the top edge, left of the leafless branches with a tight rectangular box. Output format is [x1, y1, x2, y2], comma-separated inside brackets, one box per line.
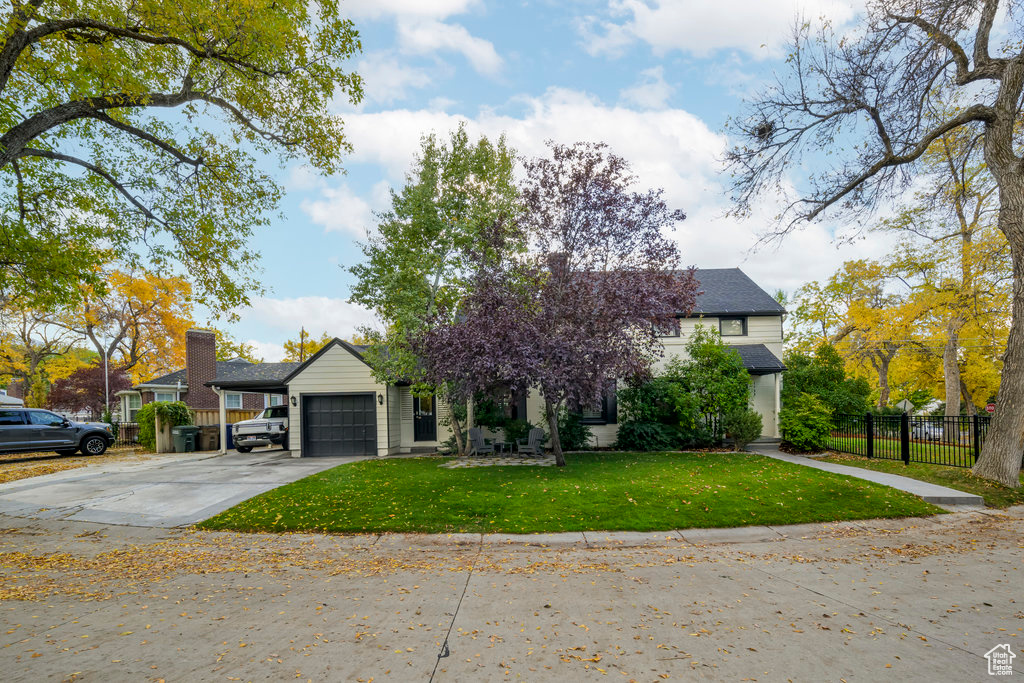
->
[579, 0, 863, 59]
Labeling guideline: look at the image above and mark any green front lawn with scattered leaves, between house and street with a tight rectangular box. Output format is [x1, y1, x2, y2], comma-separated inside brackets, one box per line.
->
[200, 453, 941, 533]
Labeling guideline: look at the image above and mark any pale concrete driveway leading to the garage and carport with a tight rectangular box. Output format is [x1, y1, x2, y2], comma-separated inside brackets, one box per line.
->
[0, 450, 364, 527]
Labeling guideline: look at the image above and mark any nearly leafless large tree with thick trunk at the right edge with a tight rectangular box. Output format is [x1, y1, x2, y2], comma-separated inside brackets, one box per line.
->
[728, 0, 1024, 487]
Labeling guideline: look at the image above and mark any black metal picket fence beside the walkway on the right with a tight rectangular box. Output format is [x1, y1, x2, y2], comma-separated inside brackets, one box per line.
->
[828, 413, 992, 467]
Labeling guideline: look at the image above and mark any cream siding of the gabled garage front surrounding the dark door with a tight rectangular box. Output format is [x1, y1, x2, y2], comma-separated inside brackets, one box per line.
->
[288, 345, 393, 456]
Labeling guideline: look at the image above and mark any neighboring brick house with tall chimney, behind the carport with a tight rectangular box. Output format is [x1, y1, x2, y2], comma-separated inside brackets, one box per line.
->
[117, 330, 299, 422]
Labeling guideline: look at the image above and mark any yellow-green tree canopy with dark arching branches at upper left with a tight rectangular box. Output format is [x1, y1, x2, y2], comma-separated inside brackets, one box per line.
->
[0, 0, 361, 308]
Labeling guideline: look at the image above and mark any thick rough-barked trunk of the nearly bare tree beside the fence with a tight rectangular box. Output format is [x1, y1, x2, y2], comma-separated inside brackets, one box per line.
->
[972, 189, 1024, 488]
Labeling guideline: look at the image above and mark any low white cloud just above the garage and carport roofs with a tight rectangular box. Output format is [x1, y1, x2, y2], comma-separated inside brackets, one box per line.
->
[239, 296, 376, 342]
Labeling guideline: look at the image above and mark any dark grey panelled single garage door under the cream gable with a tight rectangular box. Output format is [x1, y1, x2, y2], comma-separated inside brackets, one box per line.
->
[302, 394, 377, 456]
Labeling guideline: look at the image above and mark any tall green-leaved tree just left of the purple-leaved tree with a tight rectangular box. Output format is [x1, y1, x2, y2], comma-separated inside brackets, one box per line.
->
[350, 125, 525, 453]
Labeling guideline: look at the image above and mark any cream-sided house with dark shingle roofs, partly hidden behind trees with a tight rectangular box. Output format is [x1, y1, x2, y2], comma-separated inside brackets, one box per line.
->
[203, 268, 785, 456]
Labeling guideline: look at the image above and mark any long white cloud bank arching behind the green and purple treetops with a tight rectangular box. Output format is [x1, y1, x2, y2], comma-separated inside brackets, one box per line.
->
[346, 83, 890, 291]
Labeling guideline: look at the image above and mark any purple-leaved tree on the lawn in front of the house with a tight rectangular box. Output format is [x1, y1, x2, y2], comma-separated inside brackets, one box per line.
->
[424, 142, 697, 466]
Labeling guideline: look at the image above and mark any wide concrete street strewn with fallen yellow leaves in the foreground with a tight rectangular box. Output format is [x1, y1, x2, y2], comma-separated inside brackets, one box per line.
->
[0, 508, 1024, 682]
